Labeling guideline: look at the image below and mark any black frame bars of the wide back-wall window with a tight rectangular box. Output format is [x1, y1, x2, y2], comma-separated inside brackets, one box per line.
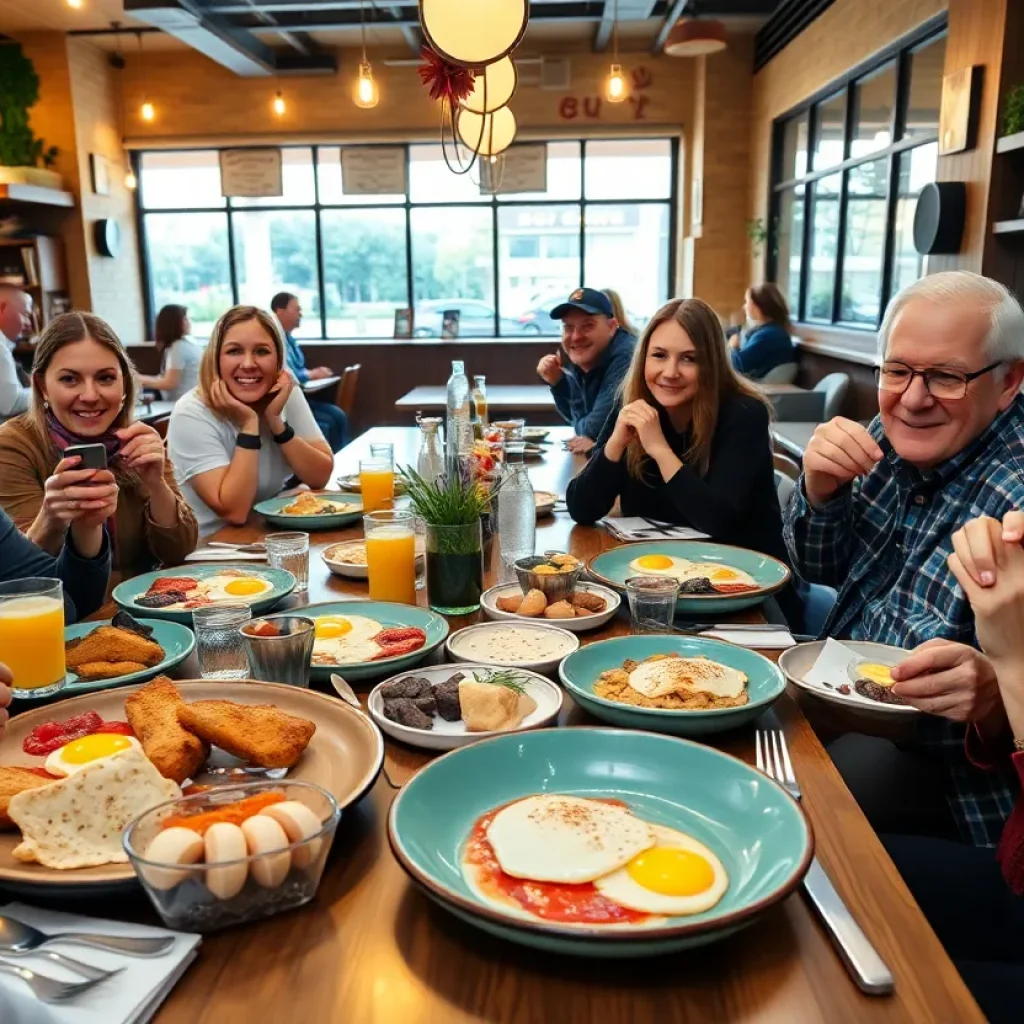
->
[130, 134, 680, 344]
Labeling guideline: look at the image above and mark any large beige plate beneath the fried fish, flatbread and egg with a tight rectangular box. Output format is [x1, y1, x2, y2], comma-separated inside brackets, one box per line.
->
[0, 680, 384, 891]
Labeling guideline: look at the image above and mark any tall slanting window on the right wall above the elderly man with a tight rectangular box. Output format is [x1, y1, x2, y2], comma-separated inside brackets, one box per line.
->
[768, 31, 946, 330]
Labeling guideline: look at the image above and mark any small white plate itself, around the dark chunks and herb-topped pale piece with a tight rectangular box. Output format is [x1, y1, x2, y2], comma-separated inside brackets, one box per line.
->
[367, 664, 562, 751]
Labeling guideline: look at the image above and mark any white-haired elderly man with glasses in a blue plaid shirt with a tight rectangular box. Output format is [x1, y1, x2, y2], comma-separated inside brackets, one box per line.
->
[784, 271, 1024, 846]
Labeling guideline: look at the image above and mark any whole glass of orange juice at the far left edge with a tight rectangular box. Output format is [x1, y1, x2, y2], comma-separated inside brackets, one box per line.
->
[0, 577, 67, 697]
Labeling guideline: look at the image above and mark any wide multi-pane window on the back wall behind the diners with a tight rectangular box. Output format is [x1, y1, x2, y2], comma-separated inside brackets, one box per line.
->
[138, 138, 679, 339]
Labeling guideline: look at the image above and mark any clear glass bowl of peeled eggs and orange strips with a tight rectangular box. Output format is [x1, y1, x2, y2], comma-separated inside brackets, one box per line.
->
[123, 781, 341, 932]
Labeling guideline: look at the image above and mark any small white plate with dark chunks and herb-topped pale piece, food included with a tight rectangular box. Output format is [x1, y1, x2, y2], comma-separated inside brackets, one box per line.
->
[367, 665, 562, 751]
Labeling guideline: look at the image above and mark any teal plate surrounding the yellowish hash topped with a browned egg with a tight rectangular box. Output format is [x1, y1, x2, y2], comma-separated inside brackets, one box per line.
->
[558, 634, 785, 736]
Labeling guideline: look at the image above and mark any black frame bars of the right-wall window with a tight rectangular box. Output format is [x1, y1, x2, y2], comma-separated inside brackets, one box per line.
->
[764, 12, 948, 332]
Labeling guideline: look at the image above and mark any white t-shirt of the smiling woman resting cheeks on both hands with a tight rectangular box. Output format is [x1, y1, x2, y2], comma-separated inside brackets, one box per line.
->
[167, 385, 324, 537]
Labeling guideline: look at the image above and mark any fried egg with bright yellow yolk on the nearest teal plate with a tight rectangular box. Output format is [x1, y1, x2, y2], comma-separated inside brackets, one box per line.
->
[594, 824, 729, 914]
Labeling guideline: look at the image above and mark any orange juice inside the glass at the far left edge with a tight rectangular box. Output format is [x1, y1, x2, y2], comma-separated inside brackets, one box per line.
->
[0, 594, 65, 690]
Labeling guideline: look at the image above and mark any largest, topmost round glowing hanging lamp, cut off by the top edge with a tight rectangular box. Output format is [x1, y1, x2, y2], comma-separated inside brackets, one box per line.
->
[420, 0, 529, 68]
